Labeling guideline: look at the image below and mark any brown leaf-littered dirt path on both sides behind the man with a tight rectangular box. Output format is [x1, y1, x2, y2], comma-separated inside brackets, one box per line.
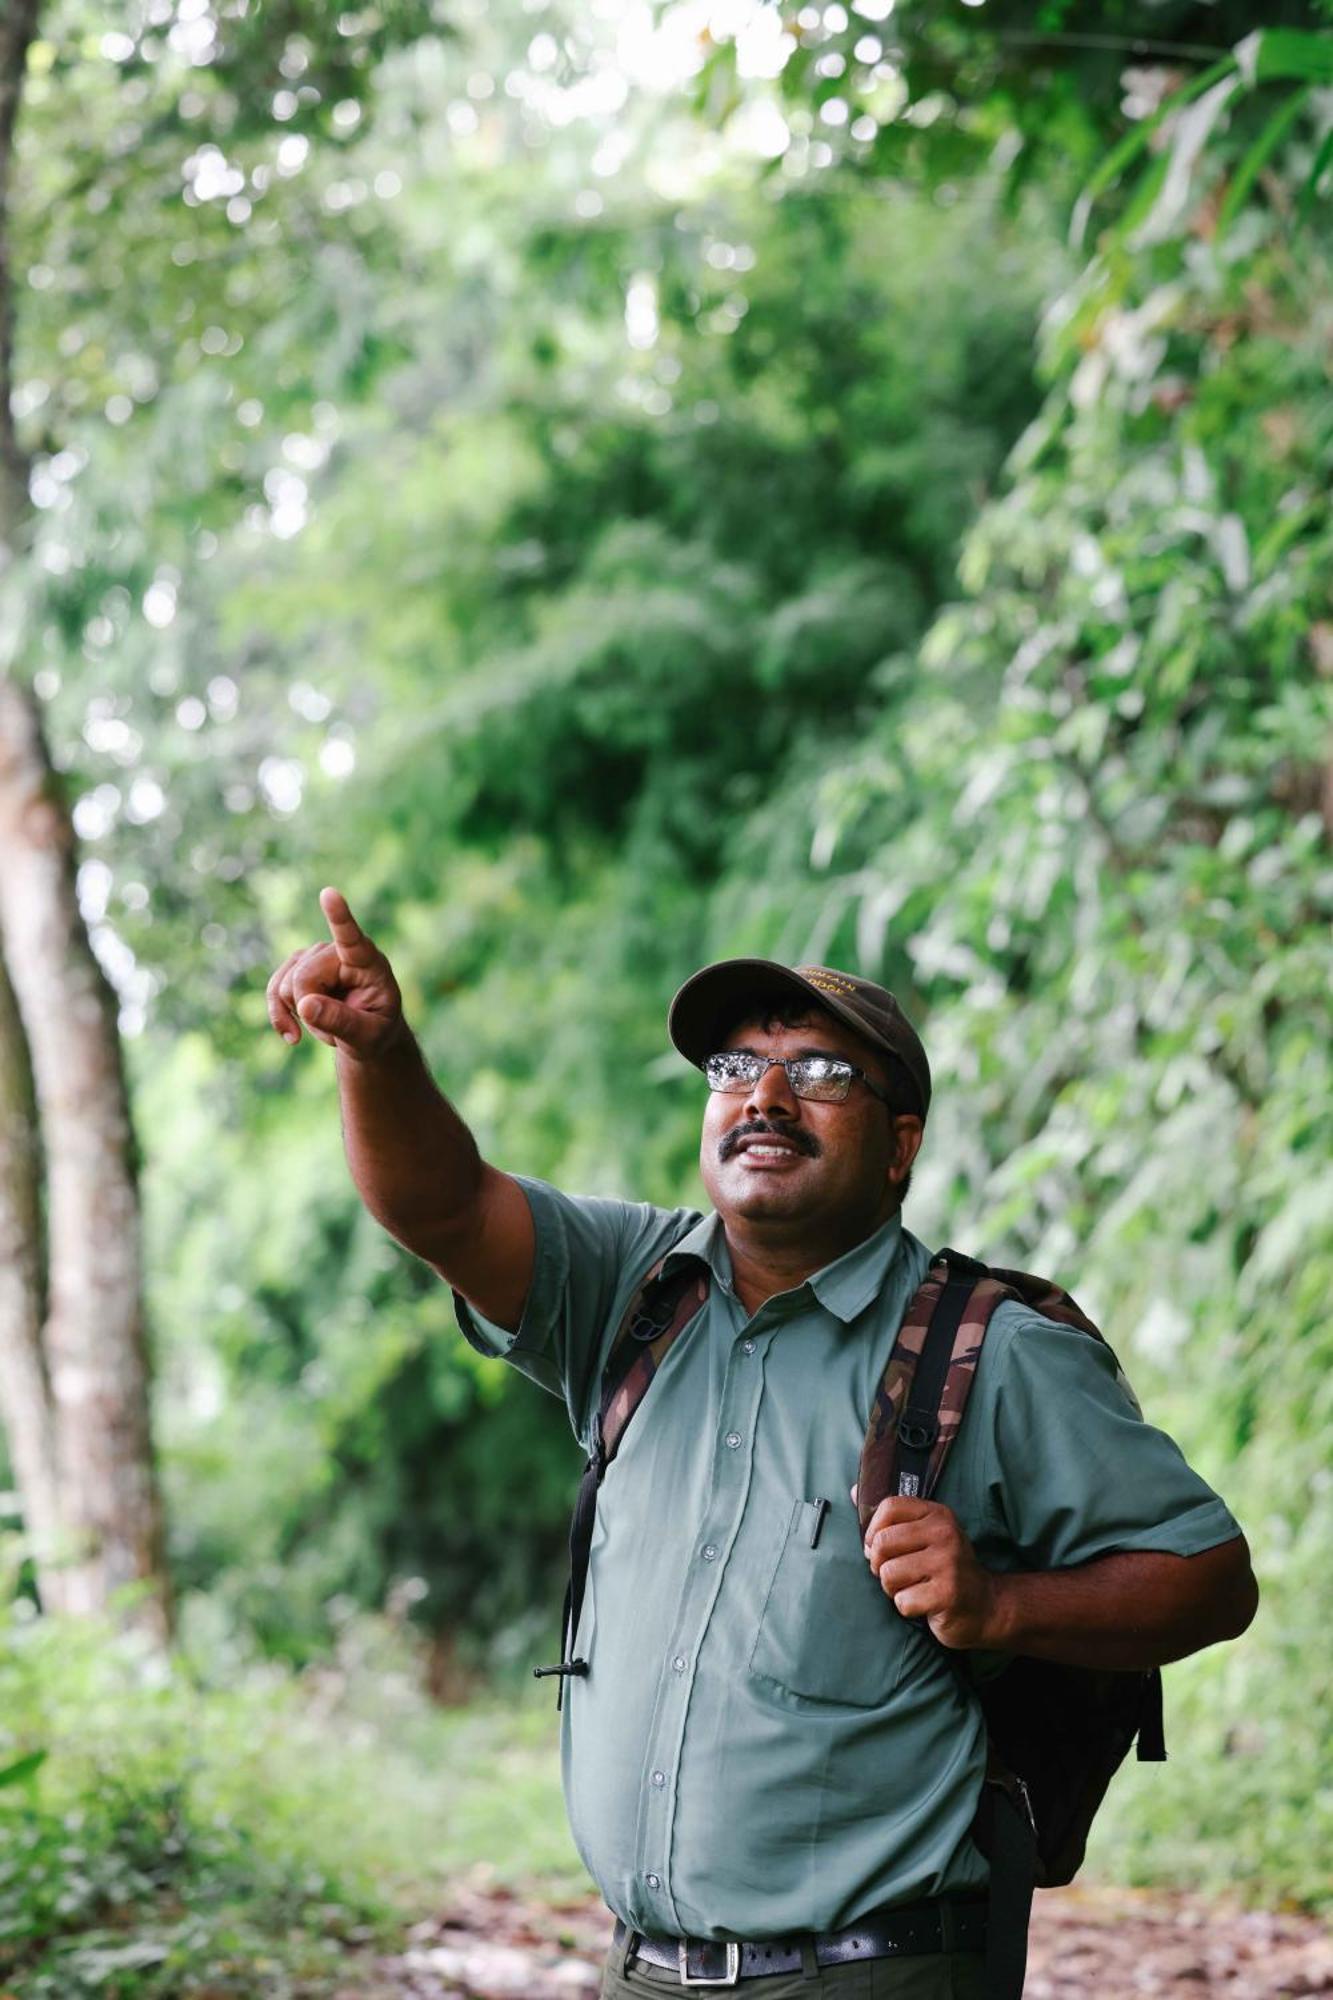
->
[350, 1888, 1333, 2000]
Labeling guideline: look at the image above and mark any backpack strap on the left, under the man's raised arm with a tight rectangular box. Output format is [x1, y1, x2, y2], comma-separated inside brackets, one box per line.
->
[532, 1256, 709, 1708]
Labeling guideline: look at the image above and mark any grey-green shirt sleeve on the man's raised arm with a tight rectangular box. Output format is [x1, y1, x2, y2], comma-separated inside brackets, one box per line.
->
[454, 1174, 699, 1446]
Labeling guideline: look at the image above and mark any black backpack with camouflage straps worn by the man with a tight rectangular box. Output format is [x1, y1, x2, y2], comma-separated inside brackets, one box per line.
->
[534, 1250, 1167, 2000]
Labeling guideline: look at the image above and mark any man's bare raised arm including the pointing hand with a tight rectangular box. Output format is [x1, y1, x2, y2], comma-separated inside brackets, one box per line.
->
[268, 888, 534, 1328]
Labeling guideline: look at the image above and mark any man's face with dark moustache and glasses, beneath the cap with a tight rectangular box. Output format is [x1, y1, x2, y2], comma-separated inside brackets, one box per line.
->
[699, 1010, 921, 1240]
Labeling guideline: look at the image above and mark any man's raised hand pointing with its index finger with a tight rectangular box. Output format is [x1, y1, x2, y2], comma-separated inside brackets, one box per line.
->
[268, 888, 406, 1060]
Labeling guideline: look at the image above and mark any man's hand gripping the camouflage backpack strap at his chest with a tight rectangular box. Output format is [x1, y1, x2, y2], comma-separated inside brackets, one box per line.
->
[865, 1498, 1003, 1650]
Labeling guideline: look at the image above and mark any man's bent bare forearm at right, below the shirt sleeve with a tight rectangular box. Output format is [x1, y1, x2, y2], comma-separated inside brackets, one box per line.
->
[985, 1540, 1259, 1672]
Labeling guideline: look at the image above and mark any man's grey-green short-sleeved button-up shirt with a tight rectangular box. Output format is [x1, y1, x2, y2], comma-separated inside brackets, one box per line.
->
[458, 1180, 1241, 1938]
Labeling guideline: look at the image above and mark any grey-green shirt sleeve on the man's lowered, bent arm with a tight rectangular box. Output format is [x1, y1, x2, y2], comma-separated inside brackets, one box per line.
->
[967, 1304, 1241, 1570]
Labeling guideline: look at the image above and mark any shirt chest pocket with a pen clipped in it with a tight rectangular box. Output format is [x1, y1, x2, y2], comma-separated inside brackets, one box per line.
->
[751, 1500, 935, 1708]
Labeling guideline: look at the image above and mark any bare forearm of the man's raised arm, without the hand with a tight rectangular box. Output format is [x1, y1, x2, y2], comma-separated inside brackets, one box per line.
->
[336, 1024, 482, 1256]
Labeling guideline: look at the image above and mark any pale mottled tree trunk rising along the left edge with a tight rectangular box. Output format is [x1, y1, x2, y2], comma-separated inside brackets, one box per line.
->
[0, 0, 170, 1640]
